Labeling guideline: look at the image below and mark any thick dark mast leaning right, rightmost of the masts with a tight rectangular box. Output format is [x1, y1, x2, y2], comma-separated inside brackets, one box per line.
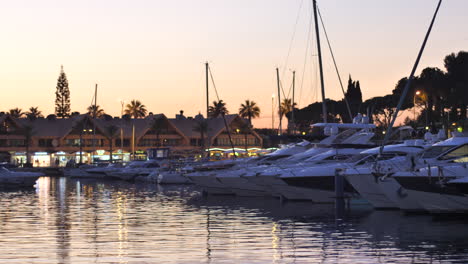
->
[378, 0, 442, 154]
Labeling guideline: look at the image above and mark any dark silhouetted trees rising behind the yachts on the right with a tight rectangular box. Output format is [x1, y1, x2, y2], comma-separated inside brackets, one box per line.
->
[287, 51, 468, 131]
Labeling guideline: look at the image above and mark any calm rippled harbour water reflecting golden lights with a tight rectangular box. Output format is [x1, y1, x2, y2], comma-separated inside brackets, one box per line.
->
[0, 177, 468, 263]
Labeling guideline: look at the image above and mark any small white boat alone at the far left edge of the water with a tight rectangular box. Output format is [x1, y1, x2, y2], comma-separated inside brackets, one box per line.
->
[0, 167, 44, 189]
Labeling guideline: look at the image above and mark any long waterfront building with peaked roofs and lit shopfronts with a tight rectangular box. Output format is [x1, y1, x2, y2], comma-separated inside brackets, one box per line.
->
[0, 114, 262, 167]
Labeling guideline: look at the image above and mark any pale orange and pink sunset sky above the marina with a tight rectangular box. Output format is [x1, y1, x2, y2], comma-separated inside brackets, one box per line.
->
[0, 0, 468, 127]
